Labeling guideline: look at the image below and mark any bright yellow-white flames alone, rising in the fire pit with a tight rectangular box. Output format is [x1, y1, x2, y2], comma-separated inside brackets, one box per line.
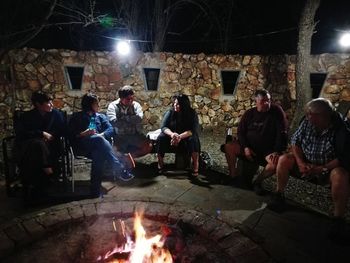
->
[99, 212, 173, 263]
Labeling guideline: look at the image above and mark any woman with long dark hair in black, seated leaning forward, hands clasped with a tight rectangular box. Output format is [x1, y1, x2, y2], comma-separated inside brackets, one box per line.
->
[157, 94, 200, 176]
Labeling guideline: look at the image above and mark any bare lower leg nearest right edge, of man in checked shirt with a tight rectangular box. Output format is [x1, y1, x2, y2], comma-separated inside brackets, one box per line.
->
[330, 167, 349, 217]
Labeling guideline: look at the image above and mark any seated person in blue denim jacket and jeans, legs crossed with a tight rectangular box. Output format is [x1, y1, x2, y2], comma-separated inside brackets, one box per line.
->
[69, 93, 134, 197]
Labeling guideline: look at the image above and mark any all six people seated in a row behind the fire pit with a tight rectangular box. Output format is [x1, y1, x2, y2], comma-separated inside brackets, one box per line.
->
[15, 86, 350, 241]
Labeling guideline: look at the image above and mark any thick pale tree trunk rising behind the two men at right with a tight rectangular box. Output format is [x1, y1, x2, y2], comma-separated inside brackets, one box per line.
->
[290, 0, 321, 132]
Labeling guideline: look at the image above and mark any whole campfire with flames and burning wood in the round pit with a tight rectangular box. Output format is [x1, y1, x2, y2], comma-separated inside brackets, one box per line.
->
[97, 212, 174, 263]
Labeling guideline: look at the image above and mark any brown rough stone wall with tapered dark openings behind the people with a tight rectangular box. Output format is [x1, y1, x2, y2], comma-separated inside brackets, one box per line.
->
[0, 48, 350, 142]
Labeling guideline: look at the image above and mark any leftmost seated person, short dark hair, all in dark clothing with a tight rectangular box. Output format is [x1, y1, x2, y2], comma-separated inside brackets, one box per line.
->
[15, 91, 65, 197]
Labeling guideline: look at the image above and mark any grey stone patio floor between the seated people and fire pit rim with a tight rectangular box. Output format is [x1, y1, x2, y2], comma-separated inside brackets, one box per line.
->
[0, 133, 350, 263]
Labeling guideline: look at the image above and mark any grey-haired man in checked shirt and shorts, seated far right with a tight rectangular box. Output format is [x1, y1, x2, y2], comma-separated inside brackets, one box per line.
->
[269, 98, 350, 241]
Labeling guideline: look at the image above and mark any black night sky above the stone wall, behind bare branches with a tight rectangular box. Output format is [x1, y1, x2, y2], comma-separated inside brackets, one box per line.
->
[1, 0, 350, 54]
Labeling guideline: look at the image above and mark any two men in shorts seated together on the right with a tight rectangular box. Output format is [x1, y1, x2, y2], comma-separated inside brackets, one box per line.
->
[224, 90, 350, 242]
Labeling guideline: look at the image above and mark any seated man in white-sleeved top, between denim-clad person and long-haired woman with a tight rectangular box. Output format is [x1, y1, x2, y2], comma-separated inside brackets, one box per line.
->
[107, 86, 152, 161]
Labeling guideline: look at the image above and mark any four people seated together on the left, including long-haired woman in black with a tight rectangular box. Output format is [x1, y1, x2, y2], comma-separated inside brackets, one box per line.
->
[15, 86, 200, 200]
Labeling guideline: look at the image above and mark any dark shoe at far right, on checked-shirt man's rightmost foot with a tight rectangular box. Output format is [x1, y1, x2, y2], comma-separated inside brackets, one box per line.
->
[327, 217, 350, 245]
